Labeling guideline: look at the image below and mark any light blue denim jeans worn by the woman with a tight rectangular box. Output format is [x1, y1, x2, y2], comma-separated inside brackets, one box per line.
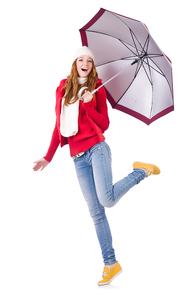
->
[74, 141, 146, 265]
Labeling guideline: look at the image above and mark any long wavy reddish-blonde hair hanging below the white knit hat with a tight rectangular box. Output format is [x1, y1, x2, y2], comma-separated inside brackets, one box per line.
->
[63, 59, 98, 106]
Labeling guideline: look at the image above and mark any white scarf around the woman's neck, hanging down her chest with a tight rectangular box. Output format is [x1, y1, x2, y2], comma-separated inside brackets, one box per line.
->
[60, 77, 87, 137]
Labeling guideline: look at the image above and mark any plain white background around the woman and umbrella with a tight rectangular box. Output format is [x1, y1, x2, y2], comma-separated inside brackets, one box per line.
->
[0, 0, 196, 296]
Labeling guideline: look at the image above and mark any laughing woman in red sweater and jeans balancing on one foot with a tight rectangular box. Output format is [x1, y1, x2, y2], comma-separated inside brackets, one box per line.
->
[33, 46, 160, 285]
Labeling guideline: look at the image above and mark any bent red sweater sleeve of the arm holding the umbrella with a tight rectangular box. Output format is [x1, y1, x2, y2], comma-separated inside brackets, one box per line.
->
[83, 87, 109, 132]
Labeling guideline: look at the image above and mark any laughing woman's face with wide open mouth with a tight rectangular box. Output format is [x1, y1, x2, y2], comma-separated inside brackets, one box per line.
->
[76, 55, 93, 78]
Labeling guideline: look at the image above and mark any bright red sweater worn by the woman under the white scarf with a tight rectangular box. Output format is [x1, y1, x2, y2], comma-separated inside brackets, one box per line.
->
[44, 79, 109, 162]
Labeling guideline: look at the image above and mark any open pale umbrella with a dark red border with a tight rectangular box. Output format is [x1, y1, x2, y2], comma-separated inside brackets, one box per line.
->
[79, 8, 174, 125]
